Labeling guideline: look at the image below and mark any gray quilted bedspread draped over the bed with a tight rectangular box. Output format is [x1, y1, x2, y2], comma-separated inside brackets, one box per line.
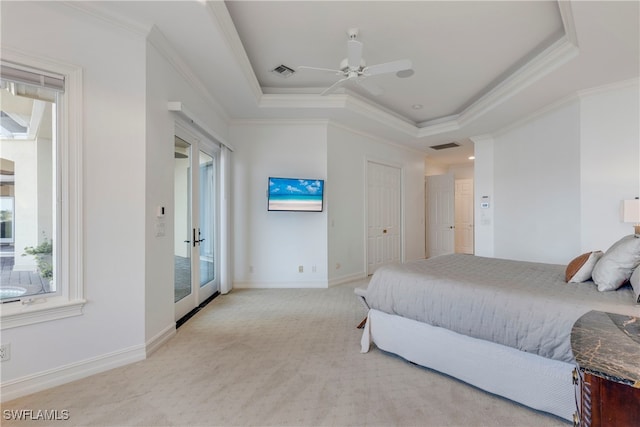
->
[366, 254, 640, 362]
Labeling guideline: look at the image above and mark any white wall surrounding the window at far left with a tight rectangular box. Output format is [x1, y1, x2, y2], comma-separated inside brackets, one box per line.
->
[2, 2, 145, 388]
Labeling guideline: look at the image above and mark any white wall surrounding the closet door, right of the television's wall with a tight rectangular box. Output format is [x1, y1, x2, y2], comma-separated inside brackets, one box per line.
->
[327, 125, 425, 283]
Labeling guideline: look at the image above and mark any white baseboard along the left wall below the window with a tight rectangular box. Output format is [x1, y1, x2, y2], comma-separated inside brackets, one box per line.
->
[0, 345, 145, 402]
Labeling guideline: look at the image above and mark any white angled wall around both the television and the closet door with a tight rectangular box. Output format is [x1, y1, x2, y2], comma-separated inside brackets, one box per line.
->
[231, 122, 424, 287]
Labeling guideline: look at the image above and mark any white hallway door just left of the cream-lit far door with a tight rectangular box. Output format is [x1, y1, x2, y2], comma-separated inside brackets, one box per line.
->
[427, 174, 455, 257]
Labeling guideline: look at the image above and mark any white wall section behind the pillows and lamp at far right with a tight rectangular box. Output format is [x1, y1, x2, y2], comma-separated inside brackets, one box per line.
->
[580, 80, 640, 252]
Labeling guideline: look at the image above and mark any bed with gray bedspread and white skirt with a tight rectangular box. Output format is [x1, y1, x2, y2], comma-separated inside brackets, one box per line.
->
[356, 251, 640, 420]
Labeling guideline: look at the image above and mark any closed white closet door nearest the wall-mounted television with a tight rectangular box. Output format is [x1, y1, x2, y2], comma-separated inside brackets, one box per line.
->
[367, 162, 402, 274]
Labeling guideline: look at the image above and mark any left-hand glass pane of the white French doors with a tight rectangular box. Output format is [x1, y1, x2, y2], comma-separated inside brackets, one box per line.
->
[174, 137, 193, 302]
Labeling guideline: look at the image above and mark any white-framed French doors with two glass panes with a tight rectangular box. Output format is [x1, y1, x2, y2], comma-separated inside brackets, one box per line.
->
[174, 128, 219, 320]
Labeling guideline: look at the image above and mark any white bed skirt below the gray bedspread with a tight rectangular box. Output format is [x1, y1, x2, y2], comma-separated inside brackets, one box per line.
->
[361, 309, 576, 421]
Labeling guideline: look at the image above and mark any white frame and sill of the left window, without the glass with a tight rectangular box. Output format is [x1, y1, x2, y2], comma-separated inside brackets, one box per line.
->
[0, 50, 86, 330]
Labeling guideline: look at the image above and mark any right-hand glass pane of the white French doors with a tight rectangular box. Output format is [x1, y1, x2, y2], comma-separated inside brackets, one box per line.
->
[198, 151, 216, 287]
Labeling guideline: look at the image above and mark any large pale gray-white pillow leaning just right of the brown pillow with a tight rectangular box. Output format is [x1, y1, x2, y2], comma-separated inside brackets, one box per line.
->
[591, 234, 640, 292]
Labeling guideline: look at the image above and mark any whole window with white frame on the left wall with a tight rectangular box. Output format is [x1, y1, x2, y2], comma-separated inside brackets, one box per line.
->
[0, 52, 84, 329]
